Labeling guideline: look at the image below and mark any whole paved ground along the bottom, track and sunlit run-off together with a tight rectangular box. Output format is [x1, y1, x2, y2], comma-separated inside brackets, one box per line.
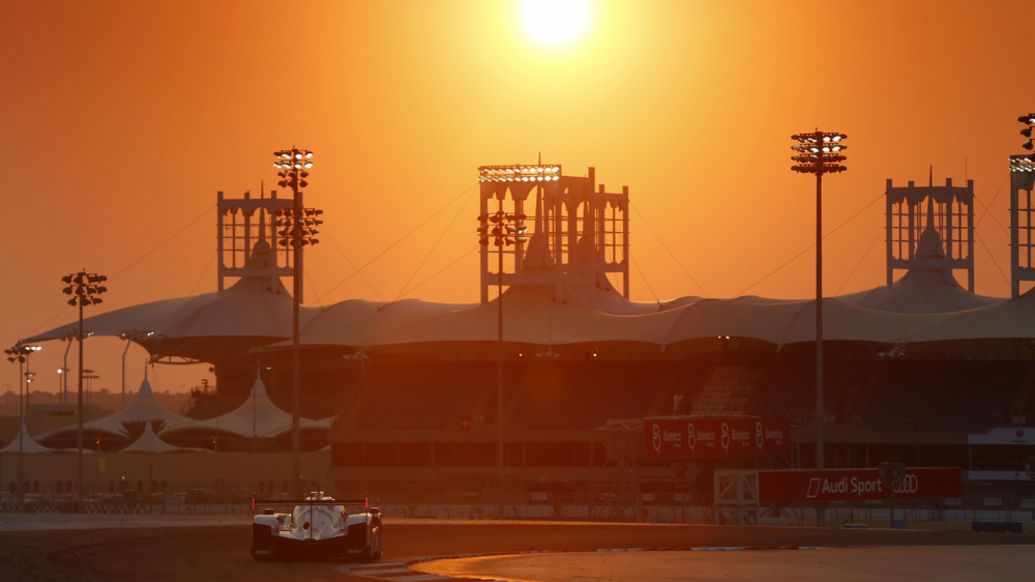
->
[0, 515, 1035, 582]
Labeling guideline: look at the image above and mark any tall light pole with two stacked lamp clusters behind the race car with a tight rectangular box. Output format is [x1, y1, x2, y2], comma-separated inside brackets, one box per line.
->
[273, 146, 323, 499]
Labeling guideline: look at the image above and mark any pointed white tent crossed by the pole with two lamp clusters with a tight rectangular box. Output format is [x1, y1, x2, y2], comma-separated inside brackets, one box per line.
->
[169, 378, 333, 438]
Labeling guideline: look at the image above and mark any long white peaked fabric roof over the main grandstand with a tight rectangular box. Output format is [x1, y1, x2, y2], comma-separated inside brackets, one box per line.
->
[22, 255, 1035, 352]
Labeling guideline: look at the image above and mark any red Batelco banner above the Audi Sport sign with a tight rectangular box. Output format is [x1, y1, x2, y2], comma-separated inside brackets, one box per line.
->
[644, 416, 791, 459]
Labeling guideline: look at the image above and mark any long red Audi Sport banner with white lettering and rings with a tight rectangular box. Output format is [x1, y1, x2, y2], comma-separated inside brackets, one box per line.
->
[759, 467, 963, 504]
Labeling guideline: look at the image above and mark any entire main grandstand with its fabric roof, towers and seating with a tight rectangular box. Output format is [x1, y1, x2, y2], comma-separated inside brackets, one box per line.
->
[14, 163, 1035, 507]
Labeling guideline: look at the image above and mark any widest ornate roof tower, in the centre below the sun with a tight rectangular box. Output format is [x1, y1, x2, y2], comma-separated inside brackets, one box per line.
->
[478, 164, 629, 303]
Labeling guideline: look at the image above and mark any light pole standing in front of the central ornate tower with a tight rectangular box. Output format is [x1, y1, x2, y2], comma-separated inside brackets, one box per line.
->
[477, 197, 528, 519]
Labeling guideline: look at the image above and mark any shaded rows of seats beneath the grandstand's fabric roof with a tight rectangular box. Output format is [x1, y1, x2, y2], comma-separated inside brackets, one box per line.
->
[344, 352, 1031, 432]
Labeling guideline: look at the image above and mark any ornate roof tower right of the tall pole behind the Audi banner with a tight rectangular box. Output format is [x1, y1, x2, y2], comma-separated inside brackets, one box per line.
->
[885, 171, 974, 293]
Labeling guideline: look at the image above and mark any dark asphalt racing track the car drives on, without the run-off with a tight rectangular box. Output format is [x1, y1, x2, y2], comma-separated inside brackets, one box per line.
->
[0, 518, 1035, 582]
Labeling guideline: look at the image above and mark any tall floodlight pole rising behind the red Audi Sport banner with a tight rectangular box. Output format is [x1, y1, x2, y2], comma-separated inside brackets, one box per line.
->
[791, 129, 848, 525]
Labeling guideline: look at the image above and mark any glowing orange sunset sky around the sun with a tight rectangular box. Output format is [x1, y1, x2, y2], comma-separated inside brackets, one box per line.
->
[0, 0, 1035, 390]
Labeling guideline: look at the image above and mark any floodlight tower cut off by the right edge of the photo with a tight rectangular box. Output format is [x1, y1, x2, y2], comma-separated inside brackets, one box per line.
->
[1010, 113, 1035, 297]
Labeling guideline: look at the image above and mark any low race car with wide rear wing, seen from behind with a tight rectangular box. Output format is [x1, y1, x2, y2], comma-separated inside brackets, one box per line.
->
[252, 491, 382, 561]
